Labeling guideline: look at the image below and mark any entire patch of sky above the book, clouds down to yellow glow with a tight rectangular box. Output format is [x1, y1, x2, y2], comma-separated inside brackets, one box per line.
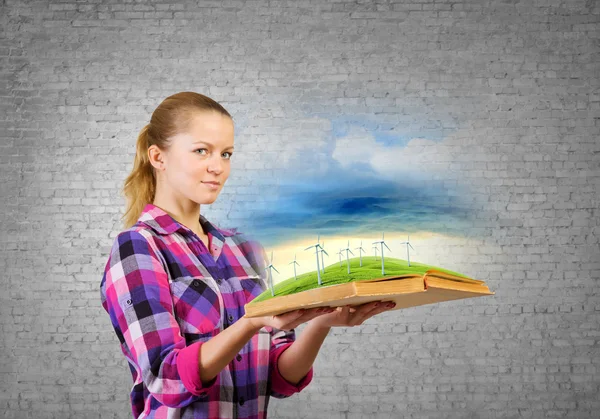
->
[227, 119, 480, 282]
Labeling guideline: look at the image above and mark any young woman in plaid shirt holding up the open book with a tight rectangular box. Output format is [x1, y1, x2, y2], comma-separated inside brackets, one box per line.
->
[100, 92, 390, 418]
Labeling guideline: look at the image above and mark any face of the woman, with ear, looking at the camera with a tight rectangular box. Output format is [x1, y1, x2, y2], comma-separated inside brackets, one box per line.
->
[150, 112, 233, 204]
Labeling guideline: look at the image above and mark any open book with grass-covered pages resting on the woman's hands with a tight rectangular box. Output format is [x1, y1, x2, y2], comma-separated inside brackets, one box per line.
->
[244, 257, 495, 317]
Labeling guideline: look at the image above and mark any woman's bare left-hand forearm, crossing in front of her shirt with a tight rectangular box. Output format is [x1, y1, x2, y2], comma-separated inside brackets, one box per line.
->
[198, 317, 260, 383]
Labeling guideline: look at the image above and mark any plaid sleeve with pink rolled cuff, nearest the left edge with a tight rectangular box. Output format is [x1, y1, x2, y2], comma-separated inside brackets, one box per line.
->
[102, 231, 217, 408]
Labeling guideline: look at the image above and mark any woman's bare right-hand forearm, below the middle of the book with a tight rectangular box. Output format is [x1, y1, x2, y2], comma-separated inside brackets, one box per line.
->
[278, 322, 331, 384]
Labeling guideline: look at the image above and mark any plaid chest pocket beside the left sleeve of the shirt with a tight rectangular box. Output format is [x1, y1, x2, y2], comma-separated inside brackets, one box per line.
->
[171, 276, 222, 337]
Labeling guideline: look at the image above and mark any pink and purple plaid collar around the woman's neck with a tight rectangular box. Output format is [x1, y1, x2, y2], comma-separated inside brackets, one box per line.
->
[138, 203, 237, 246]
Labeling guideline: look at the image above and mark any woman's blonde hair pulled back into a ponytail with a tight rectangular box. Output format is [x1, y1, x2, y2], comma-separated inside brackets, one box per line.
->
[121, 92, 233, 229]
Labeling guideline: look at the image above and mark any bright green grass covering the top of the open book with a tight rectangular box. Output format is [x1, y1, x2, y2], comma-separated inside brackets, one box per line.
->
[250, 256, 469, 304]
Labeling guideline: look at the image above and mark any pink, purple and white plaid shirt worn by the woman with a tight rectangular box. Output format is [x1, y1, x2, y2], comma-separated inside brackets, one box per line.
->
[100, 204, 313, 419]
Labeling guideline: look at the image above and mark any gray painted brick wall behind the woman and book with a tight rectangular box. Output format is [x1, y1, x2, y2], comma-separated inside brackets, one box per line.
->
[0, 0, 600, 419]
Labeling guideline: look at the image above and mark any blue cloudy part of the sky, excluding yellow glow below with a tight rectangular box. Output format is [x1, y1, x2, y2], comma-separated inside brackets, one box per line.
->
[232, 119, 471, 246]
